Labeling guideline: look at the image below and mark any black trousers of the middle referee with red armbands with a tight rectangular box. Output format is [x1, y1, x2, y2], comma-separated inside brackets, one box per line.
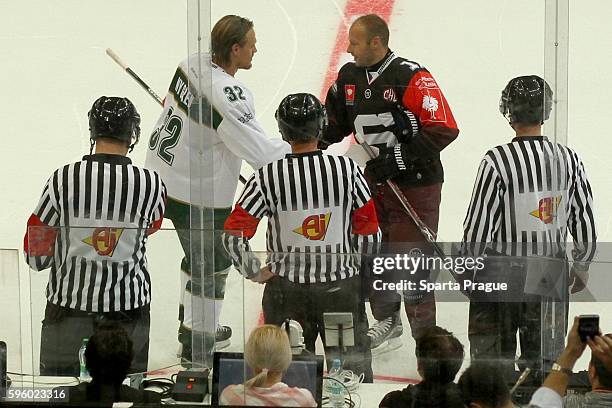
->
[262, 276, 373, 382]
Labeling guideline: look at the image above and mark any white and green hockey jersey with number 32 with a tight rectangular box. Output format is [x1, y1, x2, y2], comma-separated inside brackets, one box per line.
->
[145, 53, 291, 208]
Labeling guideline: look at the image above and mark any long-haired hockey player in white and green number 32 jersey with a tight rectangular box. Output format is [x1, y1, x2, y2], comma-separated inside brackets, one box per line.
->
[146, 15, 290, 361]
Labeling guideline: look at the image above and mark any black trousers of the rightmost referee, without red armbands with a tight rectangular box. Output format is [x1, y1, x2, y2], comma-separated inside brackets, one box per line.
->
[468, 256, 568, 382]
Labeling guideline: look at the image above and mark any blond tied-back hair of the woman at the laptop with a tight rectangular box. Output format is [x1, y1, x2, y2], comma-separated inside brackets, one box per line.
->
[244, 324, 291, 388]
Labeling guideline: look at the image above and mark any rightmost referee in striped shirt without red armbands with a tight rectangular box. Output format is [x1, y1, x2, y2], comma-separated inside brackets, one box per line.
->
[463, 75, 596, 378]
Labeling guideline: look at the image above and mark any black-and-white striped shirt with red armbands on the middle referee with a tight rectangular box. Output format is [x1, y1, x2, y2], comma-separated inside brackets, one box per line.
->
[224, 151, 381, 283]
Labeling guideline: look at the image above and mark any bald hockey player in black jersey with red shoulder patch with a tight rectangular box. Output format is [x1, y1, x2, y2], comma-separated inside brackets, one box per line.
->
[321, 14, 459, 350]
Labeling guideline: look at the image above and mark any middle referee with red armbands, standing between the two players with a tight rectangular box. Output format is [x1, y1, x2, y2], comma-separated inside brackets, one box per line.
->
[224, 94, 380, 382]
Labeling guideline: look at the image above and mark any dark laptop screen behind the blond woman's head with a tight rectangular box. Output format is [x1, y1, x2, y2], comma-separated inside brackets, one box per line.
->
[212, 352, 323, 406]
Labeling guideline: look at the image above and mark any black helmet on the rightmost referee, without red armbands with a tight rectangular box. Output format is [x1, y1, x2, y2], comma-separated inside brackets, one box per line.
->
[499, 75, 553, 124]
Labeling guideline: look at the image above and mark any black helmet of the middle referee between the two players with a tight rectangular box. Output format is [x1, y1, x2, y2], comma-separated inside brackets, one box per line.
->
[274, 93, 327, 143]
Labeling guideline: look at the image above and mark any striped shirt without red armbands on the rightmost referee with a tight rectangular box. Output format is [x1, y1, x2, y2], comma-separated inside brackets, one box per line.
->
[463, 136, 596, 261]
